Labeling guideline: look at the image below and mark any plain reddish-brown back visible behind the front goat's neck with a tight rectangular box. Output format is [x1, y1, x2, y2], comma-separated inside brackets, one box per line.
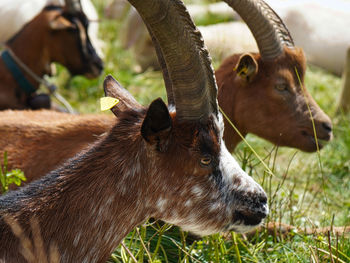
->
[0, 110, 115, 189]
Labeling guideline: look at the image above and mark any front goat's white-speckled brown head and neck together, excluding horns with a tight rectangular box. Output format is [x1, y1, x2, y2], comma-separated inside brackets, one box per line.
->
[0, 78, 268, 263]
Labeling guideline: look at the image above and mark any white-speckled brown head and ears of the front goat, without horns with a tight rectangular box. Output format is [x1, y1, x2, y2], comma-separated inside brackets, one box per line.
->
[105, 77, 268, 235]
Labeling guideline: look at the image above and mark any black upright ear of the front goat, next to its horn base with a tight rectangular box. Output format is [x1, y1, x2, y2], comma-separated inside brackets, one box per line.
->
[141, 98, 172, 151]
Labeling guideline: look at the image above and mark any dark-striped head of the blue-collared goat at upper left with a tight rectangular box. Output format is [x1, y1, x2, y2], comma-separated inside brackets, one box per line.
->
[42, 0, 103, 78]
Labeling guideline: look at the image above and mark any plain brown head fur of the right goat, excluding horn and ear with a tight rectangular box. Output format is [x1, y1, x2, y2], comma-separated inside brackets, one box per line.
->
[216, 48, 332, 152]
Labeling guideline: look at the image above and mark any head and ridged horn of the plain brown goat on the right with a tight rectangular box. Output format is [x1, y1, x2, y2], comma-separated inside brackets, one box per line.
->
[217, 0, 332, 152]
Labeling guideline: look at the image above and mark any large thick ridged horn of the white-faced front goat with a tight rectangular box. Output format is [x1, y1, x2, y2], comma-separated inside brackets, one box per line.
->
[129, 0, 218, 120]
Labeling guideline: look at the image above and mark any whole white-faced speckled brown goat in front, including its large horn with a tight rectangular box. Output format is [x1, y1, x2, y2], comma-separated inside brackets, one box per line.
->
[0, 0, 268, 262]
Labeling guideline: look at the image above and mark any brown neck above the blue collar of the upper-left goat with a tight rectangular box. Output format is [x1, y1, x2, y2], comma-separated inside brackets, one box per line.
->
[6, 27, 51, 88]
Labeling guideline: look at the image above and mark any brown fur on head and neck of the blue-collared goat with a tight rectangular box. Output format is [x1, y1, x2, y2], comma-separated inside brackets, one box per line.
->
[0, 7, 102, 110]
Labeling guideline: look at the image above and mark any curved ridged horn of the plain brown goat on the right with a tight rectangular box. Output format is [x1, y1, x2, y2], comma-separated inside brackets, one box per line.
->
[224, 0, 294, 60]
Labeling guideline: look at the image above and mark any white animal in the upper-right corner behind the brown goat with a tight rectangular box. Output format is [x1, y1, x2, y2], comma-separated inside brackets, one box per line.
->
[266, 0, 350, 75]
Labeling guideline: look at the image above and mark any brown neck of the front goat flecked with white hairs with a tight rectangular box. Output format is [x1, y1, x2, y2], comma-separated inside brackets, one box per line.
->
[0, 124, 152, 262]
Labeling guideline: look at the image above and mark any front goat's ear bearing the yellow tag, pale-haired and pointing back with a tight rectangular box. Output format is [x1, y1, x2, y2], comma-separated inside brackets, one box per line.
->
[103, 75, 142, 117]
